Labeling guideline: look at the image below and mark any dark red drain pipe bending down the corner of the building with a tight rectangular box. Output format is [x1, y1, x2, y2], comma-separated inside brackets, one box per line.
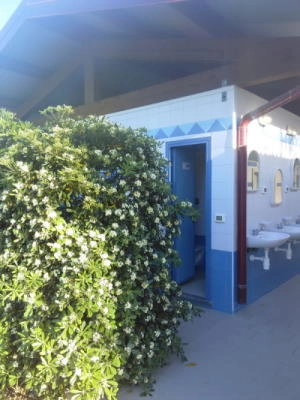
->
[237, 85, 300, 304]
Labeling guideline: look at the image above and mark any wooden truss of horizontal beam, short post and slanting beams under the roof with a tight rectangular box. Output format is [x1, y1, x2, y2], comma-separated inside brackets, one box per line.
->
[14, 34, 300, 117]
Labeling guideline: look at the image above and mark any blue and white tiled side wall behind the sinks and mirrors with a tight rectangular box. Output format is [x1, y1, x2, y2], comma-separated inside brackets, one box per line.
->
[234, 88, 300, 302]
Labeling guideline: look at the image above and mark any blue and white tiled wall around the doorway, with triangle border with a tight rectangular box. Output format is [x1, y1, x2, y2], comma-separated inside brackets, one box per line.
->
[108, 87, 236, 312]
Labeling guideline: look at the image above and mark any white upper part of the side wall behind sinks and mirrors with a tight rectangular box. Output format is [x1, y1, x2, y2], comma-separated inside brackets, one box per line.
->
[235, 88, 300, 231]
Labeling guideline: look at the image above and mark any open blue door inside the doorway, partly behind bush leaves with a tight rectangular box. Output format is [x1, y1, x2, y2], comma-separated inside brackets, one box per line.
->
[171, 146, 196, 283]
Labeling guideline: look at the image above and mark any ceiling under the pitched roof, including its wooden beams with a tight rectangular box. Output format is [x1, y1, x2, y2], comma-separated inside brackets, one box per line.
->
[0, 0, 300, 118]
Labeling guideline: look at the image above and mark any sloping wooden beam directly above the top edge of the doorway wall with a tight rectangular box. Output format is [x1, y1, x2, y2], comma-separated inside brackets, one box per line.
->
[77, 51, 300, 115]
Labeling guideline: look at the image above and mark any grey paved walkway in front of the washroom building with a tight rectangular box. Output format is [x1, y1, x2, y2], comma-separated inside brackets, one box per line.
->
[119, 275, 300, 400]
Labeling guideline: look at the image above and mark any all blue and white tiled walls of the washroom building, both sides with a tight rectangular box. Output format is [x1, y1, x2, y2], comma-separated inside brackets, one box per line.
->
[108, 86, 300, 313]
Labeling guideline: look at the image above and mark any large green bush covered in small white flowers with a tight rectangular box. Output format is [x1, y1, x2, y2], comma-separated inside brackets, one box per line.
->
[0, 107, 199, 400]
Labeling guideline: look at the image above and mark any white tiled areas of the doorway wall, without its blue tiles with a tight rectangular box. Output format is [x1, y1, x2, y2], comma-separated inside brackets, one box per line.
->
[108, 86, 236, 252]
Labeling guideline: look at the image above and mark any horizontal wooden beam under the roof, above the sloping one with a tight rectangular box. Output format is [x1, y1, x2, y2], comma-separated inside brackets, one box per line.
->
[86, 37, 300, 63]
